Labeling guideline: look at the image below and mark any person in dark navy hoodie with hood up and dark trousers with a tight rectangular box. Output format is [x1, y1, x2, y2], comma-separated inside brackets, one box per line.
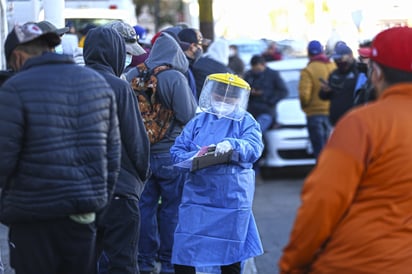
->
[83, 27, 149, 274]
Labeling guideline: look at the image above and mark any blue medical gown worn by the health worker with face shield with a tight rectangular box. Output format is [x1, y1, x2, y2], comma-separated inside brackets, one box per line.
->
[170, 113, 263, 267]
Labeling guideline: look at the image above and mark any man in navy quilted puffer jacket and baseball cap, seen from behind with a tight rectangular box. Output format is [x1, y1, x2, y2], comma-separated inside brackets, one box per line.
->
[0, 23, 121, 274]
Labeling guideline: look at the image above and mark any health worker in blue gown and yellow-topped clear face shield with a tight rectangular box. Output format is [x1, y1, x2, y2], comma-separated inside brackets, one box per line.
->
[170, 73, 263, 274]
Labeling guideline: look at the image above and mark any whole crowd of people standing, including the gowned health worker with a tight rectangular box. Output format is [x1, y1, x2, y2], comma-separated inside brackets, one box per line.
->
[0, 16, 412, 274]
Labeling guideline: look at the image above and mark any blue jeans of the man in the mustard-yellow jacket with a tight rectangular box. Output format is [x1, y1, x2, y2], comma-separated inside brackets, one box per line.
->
[306, 115, 332, 158]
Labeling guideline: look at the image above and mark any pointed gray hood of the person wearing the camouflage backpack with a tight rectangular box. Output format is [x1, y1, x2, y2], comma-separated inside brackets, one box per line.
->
[144, 32, 189, 73]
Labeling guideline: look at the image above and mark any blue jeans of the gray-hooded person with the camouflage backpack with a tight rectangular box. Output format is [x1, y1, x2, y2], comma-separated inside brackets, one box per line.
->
[138, 153, 187, 273]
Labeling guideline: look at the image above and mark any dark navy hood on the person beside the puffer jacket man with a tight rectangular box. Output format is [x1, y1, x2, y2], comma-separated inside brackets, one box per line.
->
[83, 27, 126, 76]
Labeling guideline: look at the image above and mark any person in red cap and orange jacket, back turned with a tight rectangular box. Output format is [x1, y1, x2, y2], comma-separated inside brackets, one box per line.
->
[279, 27, 412, 274]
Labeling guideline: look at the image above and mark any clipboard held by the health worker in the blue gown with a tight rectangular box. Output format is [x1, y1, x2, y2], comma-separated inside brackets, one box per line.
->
[190, 147, 239, 171]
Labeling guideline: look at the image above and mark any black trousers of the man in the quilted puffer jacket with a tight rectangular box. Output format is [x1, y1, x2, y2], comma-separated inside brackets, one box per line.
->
[9, 217, 96, 274]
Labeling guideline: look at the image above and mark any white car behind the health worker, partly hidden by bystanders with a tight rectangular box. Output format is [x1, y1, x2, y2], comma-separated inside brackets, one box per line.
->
[259, 58, 316, 173]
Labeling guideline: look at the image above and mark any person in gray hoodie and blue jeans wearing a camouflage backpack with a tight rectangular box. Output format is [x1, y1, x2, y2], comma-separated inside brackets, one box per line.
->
[139, 33, 197, 274]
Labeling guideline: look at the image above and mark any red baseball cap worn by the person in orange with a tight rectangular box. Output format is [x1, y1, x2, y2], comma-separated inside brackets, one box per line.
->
[370, 27, 412, 72]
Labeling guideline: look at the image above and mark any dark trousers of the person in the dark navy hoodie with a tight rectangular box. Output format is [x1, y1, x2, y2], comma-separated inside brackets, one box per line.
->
[96, 195, 140, 274]
